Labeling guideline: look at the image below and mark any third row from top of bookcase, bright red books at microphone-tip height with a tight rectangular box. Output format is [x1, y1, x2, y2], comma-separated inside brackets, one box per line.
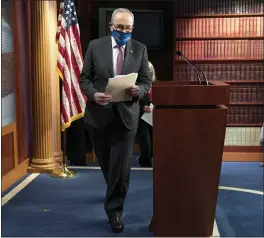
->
[176, 40, 264, 60]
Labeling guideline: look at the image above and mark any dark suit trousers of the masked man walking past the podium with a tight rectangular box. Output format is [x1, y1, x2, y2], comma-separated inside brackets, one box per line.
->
[93, 107, 136, 218]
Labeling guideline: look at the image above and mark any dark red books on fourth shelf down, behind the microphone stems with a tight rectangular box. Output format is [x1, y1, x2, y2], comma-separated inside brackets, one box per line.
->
[175, 63, 264, 83]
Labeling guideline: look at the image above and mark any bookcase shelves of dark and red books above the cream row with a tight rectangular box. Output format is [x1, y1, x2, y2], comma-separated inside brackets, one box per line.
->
[174, 0, 264, 127]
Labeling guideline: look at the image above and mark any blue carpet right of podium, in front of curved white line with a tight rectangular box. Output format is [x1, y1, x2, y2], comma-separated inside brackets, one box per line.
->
[216, 190, 264, 237]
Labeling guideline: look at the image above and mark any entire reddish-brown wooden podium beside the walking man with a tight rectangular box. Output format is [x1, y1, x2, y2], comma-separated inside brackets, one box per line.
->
[150, 81, 230, 237]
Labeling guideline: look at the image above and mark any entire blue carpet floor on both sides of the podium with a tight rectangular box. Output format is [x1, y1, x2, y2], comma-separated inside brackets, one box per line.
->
[2, 162, 264, 237]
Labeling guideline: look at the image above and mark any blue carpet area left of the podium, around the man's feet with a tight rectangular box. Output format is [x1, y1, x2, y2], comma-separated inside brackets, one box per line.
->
[2, 170, 152, 236]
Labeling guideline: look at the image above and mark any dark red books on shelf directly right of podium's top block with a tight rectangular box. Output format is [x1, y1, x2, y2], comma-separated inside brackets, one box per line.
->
[230, 85, 264, 102]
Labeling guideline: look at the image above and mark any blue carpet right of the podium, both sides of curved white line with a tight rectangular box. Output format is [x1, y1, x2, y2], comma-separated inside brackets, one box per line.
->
[216, 162, 264, 237]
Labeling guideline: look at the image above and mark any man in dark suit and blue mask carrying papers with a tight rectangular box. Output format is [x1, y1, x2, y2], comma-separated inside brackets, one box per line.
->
[80, 8, 150, 232]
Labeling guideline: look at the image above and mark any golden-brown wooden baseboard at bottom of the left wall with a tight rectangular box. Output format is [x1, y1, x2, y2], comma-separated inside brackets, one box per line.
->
[1, 159, 29, 192]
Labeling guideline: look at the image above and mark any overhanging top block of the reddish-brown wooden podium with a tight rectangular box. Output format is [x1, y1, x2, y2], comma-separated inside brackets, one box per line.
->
[152, 81, 231, 106]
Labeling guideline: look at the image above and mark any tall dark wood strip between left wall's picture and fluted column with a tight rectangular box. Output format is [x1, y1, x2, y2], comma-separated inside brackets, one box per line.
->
[13, 0, 31, 163]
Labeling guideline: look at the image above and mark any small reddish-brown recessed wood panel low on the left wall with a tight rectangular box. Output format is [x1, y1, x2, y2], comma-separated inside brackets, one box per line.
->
[1, 132, 15, 176]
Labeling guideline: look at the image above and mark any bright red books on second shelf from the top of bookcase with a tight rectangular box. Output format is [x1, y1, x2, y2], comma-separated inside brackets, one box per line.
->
[175, 17, 264, 37]
